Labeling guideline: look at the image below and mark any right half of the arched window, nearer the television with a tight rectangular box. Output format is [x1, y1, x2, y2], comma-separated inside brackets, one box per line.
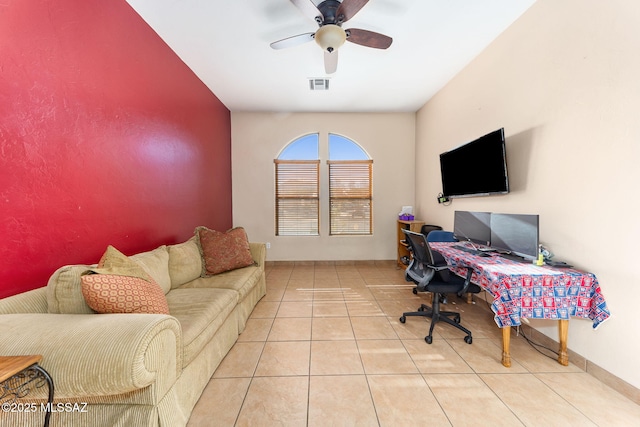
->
[327, 133, 373, 235]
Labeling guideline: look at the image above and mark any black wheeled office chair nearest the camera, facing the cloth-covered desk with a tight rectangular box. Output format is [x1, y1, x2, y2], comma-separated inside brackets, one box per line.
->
[400, 230, 481, 344]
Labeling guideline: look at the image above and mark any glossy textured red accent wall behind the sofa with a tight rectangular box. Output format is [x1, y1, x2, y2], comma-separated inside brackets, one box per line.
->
[0, 0, 232, 297]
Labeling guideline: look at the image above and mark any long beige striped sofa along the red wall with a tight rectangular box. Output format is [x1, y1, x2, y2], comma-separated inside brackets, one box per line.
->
[0, 238, 266, 427]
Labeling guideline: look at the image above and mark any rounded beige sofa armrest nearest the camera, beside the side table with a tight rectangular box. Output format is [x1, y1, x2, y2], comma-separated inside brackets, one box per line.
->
[0, 313, 182, 398]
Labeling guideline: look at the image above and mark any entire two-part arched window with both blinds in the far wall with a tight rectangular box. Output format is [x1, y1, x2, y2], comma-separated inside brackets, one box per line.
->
[274, 133, 373, 236]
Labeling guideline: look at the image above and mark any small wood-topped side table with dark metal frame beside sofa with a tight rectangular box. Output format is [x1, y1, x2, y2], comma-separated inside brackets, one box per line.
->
[0, 355, 53, 427]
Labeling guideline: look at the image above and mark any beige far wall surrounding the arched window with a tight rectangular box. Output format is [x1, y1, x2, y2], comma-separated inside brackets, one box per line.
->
[231, 113, 415, 261]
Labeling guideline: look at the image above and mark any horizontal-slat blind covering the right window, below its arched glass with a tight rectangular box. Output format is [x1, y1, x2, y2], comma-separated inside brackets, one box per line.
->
[327, 160, 373, 235]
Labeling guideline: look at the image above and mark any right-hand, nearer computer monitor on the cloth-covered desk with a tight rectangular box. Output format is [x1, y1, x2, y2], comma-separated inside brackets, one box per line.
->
[491, 213, 539, 260]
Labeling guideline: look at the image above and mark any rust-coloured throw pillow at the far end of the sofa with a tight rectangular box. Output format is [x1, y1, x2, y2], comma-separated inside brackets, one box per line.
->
[196, 227, 254, 276]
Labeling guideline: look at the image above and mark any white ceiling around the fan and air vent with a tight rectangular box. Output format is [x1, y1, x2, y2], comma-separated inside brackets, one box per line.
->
[127, 0, 535, 112]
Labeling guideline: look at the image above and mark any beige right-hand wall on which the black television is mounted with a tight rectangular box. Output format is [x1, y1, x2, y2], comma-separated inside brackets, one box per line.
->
[416, 0, 640, 387]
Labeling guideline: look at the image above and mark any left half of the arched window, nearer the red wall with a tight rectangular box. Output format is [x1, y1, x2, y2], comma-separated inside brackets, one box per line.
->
[274, 133, 320, 236]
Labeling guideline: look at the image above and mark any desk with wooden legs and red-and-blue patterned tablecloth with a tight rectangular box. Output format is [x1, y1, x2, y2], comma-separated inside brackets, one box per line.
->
[429, 242, 611, 367]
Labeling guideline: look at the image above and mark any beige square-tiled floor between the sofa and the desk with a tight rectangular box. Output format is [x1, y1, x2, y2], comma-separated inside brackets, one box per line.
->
[188, 263, 640, 427]
